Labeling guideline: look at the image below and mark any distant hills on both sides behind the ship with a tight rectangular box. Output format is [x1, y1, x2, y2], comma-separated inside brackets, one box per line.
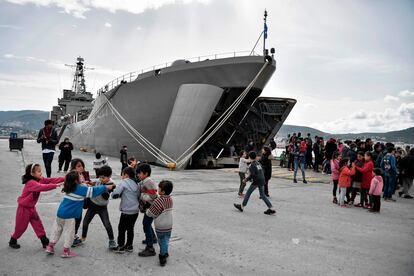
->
[0, 110, 414, 144]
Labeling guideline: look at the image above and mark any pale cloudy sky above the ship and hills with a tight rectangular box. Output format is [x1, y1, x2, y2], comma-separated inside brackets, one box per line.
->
[0, 0, 414, 133]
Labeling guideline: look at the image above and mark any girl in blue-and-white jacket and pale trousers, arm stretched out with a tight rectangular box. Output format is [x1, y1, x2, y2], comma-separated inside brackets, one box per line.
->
[46, 171, 113, 258]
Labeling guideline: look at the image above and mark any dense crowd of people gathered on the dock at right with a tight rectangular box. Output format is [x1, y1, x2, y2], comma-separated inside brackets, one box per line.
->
[280, 133, 414, 212]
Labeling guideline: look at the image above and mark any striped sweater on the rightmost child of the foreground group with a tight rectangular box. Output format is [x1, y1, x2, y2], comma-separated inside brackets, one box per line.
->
[146, 195, 173, 232]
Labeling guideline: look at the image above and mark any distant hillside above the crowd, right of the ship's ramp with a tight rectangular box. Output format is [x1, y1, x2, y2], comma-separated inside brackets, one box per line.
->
[276, 125, 414, 144]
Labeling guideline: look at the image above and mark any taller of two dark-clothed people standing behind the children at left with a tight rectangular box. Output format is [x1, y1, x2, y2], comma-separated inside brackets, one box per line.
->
[37, 120, 58, 177]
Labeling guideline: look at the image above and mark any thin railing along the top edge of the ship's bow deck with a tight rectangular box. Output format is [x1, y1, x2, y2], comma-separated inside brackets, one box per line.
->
[98, 51, 259, 95]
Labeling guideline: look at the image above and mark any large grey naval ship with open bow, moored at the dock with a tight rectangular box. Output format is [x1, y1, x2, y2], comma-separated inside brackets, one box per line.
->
[51, 17, 296, 168]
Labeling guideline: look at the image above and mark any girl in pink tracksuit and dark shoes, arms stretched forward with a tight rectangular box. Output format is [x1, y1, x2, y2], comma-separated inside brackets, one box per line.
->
[9, 164, 65, 249]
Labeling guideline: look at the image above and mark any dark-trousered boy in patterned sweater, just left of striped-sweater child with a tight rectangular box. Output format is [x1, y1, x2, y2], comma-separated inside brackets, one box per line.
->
[137, 163, 158, 257]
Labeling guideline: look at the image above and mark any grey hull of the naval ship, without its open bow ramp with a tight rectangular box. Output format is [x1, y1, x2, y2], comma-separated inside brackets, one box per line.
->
[63, 56, 292, 164]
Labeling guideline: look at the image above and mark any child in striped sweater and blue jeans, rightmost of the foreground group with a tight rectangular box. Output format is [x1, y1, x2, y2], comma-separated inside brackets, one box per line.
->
[146, 180, 173, 266]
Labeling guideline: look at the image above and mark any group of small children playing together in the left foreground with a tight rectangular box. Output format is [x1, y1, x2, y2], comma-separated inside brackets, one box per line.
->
[9, 158, 173, 266]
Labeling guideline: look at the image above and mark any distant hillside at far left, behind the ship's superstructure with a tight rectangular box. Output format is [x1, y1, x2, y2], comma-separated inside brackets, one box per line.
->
[0, 110, 49, 130]
